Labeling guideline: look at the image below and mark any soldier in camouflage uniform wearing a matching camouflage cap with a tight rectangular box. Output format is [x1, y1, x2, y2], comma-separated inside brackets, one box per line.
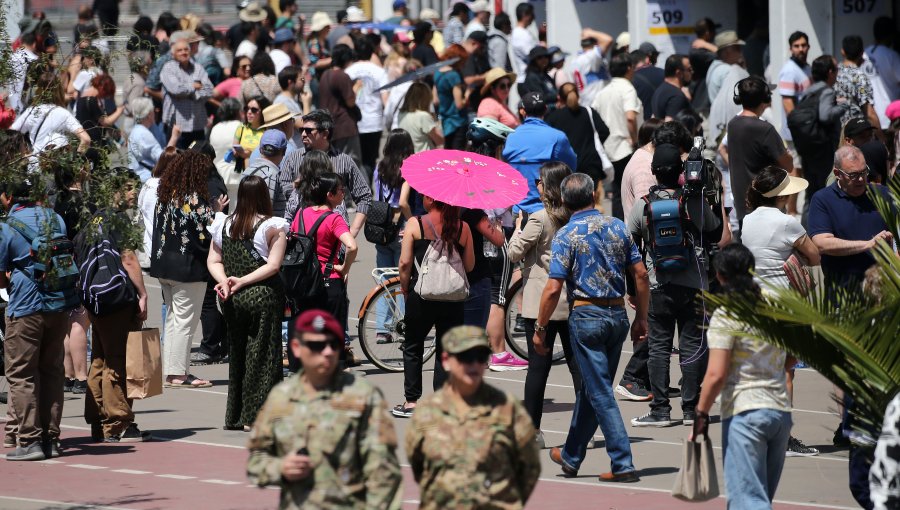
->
[406, 326, 541, 510]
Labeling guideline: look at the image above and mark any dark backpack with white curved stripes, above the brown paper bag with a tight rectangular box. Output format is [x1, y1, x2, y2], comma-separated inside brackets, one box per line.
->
[75, 215, 137, 316]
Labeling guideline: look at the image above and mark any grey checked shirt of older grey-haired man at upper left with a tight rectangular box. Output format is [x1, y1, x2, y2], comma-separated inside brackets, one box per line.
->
[160, 60, 213, 132]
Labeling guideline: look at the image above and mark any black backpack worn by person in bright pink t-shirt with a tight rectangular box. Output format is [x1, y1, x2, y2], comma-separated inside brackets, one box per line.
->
[281, 209, 337, 301]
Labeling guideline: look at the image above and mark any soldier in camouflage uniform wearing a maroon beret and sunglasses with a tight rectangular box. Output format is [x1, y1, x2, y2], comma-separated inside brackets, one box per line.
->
[247, 310, 402, 510]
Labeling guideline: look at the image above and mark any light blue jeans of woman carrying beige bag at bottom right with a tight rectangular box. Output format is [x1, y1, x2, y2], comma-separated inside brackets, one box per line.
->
[722, 409, 792, 510]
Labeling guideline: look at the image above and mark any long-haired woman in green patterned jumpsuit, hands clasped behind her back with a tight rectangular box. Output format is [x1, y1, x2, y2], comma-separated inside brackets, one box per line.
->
[206, 176, 288, 430]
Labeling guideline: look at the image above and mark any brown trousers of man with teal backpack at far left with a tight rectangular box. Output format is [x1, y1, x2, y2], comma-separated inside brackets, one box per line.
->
[4, 312, 69, 446]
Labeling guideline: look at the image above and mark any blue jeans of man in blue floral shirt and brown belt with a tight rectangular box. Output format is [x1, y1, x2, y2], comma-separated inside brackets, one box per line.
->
[562, 305, 634, 474]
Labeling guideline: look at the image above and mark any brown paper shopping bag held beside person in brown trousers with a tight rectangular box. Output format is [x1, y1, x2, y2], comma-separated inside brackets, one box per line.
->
[125, 328, 162, 399]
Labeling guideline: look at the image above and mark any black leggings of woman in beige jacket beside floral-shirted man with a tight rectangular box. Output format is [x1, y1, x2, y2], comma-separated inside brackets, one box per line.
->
[523, 319, 581, 430]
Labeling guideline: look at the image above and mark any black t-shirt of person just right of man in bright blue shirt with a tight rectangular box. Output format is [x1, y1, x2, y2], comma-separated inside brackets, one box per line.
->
[544, 108, 609, 182]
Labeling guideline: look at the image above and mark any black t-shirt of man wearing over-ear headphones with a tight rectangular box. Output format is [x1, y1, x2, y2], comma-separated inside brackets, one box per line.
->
[728, 115, 785, 221]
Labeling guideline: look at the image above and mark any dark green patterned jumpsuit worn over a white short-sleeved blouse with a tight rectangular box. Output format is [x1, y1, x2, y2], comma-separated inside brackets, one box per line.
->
[222, 222, 284, 429]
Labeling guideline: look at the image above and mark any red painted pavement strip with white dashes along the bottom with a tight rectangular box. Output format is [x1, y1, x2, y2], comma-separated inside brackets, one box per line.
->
[0, 432, 836, 510]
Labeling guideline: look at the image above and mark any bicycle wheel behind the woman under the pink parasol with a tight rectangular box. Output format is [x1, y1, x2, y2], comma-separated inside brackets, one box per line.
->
[358, 278, 435, 372]
